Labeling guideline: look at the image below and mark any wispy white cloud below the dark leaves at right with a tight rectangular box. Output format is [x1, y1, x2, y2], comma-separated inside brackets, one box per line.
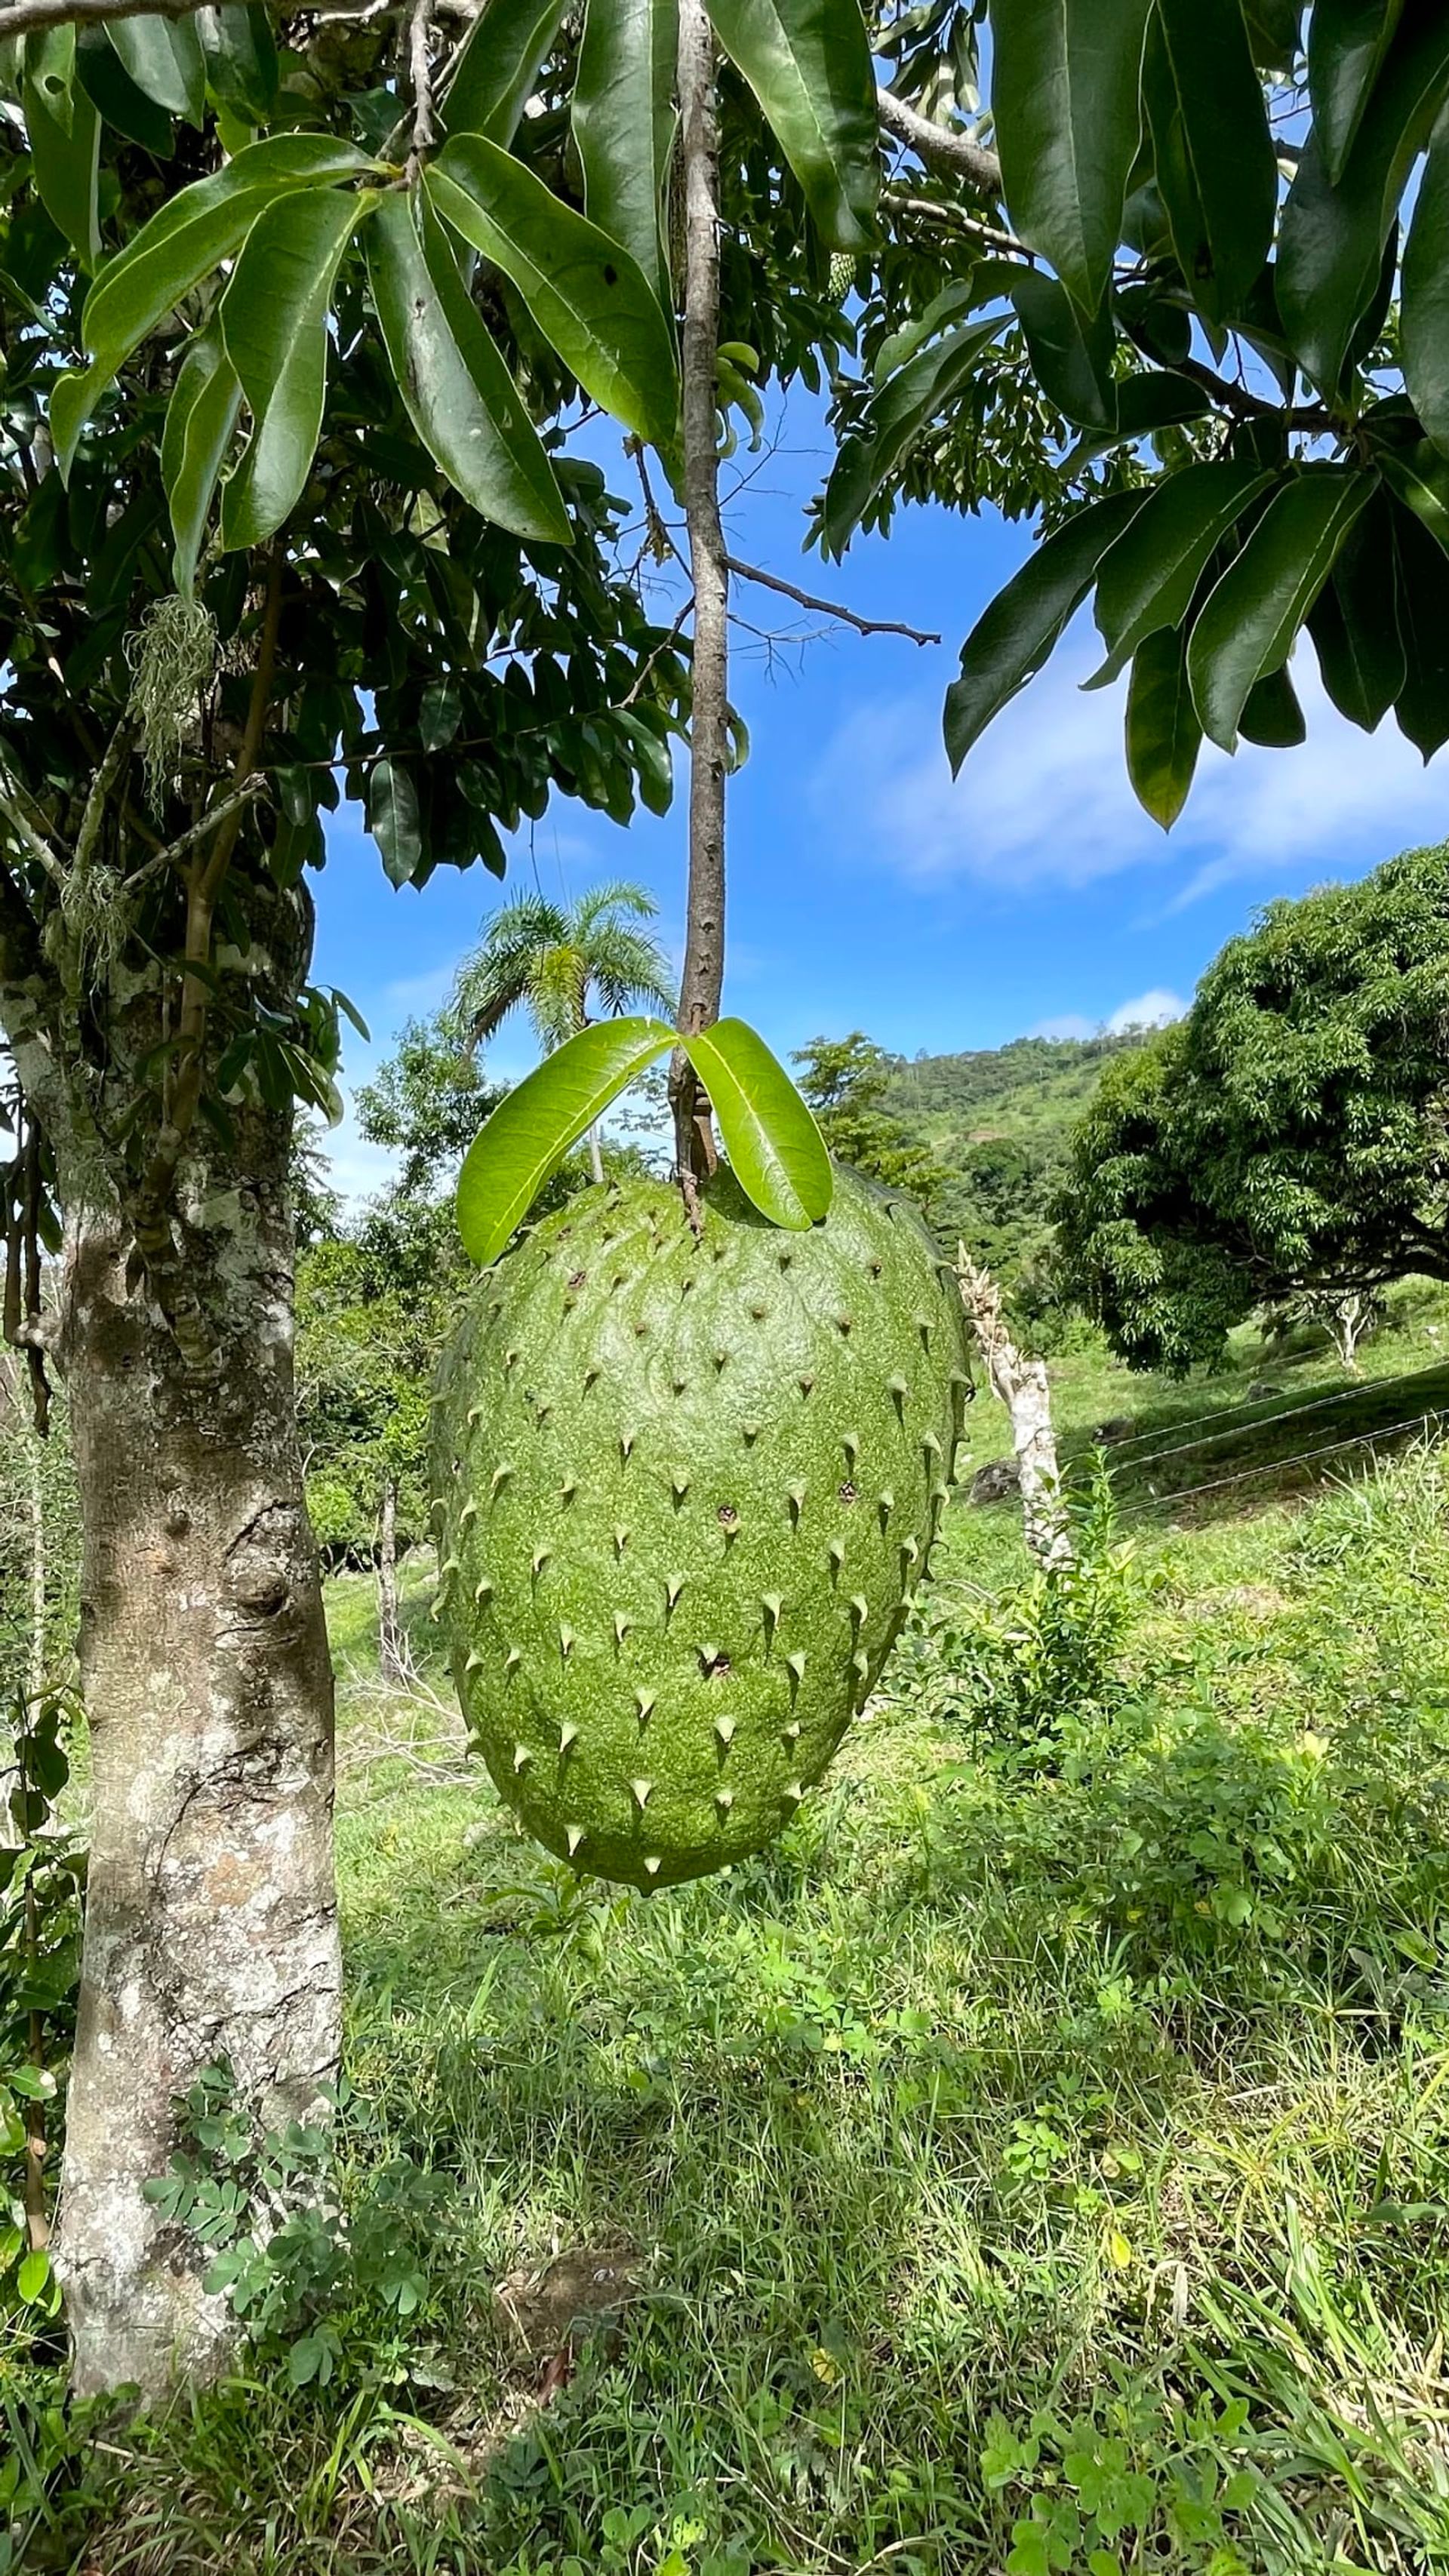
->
[815, 639, 1444, 909]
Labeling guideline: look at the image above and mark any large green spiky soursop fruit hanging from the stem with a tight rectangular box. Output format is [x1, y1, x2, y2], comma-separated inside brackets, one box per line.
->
[433, 1172, 970, 1888]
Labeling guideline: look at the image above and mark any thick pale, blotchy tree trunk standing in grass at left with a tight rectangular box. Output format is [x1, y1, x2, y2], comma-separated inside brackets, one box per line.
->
[57, 1164, 340, 2396]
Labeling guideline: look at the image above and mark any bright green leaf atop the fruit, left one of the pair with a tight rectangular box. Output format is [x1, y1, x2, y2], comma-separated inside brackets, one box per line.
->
[459, 1020, 675, 1265]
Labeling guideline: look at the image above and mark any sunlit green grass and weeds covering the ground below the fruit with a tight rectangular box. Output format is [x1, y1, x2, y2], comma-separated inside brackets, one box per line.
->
[20, 1306, 1449, 2576]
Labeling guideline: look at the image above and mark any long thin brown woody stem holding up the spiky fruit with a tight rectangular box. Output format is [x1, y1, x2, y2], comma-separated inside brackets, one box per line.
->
[670, 0, 730, 1195]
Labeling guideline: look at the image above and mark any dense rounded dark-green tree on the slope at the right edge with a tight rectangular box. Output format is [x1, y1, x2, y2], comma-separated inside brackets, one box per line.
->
[1057, 847, 1449, 1373]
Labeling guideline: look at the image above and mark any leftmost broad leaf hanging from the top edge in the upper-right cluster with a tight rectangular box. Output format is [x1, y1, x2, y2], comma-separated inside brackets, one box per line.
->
[992, 0, 1150, 315]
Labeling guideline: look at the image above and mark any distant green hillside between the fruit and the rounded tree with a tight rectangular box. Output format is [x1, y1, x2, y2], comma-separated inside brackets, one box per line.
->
[881, 1033, 1142, 1288]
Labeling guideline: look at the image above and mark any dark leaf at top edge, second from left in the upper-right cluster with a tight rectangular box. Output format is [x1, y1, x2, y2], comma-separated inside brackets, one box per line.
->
[1142, 0, 1279, 322]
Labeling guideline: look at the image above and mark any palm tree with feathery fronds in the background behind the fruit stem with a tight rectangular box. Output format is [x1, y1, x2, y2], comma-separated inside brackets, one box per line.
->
[454, 878, 675, 1180]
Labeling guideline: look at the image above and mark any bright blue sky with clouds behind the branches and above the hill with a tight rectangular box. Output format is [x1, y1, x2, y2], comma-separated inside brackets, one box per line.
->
[317, 402, 1449, 1190]
